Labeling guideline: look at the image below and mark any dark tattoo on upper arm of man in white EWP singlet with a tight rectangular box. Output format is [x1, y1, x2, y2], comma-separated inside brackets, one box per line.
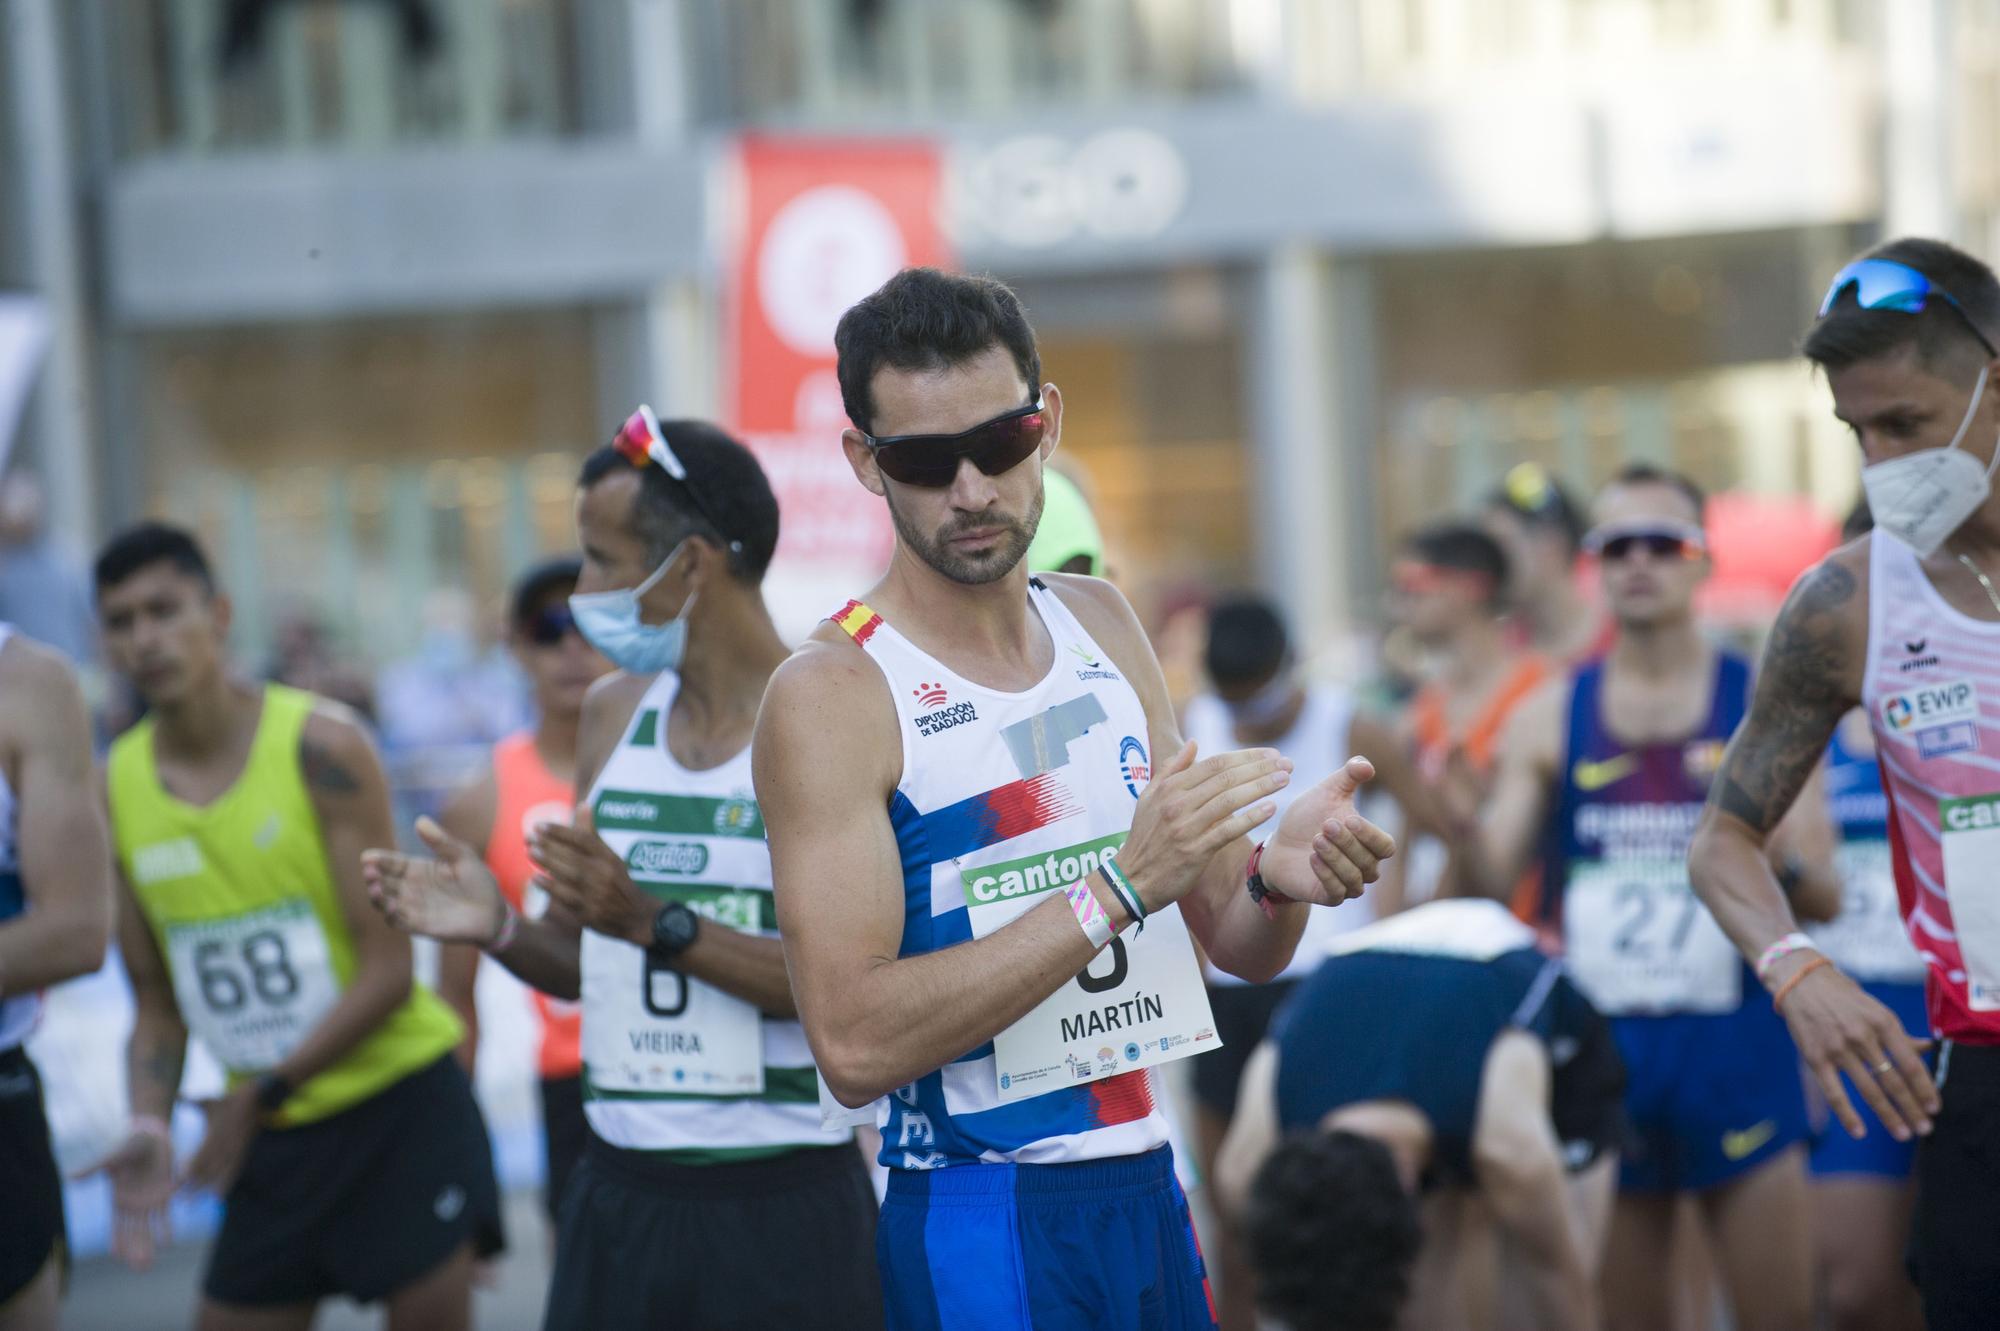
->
[1708, 564, 1856, 831]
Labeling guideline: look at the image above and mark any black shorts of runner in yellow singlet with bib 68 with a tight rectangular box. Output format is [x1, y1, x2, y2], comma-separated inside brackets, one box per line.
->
[202, 1055, 504, 1307]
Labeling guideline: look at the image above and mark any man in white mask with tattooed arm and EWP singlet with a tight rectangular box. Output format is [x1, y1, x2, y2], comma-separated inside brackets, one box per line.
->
[1690, 240, 2000, 1331]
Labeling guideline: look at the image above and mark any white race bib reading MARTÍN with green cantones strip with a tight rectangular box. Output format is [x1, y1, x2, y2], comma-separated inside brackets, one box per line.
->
[962, 835, 1222, 1101]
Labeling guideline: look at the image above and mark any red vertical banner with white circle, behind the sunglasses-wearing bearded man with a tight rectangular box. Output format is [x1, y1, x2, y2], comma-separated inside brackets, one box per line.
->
[726, 136, 950, 632]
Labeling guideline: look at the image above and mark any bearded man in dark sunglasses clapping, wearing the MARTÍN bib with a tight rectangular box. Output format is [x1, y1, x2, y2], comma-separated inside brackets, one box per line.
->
[750, 268, 1392, 1331]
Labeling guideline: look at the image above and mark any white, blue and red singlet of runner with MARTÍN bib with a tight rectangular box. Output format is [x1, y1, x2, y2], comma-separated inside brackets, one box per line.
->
[832, 580, 1220, 1169]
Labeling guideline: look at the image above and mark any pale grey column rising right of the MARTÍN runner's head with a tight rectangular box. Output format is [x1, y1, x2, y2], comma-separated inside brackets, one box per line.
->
[1244, 244, 1376, 652]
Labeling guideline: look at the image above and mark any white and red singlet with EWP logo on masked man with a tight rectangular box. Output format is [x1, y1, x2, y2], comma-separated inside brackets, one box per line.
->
[1862, 532, 2000, 1045]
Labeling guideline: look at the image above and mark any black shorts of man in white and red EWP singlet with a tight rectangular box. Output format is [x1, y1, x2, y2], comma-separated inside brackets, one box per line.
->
[1910, 1043, 2000, 1331]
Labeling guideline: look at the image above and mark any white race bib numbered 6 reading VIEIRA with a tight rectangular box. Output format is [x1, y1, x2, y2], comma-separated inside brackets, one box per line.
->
[582, 887, 770, 1095]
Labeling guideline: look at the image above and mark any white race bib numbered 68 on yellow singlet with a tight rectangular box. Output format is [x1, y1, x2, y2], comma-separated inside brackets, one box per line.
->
[166, 899, 340, 1073]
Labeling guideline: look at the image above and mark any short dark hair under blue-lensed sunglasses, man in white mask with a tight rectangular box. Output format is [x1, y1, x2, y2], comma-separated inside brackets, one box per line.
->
[1800, 236, 2000, 370]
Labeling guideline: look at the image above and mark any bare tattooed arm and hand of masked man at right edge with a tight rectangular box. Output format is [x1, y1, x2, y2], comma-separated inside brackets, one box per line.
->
[1688, 542, 1938, 1139]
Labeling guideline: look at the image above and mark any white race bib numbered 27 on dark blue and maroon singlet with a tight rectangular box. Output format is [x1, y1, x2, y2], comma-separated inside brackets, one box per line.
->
[1562, 859, 1742, 1015]
